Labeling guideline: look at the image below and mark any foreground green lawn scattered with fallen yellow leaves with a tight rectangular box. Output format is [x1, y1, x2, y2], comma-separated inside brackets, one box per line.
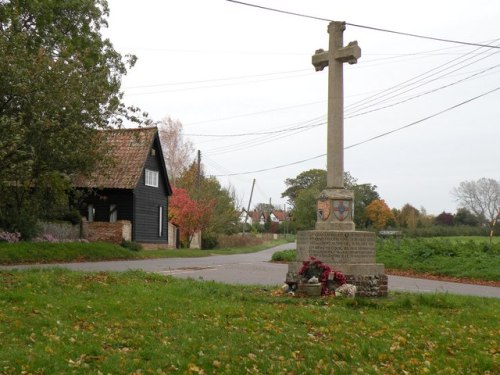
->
[0, 270, 500, 374]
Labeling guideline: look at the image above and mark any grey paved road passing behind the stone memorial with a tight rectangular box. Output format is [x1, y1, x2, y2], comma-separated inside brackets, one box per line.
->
[0, 244, 500, 298]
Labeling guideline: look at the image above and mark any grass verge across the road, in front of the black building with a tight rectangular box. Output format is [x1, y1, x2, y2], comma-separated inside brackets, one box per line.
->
[0, 240, 287, 265]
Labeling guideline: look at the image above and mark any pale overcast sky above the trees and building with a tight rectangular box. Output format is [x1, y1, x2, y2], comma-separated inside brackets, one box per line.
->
[105, 0, 500, 214]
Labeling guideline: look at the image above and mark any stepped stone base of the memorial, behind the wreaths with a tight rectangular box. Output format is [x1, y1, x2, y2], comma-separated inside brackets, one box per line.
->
[286, 230, 387, 297]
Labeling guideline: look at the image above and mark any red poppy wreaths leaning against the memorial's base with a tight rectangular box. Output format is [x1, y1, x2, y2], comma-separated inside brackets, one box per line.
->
[299, 257, 346, 295]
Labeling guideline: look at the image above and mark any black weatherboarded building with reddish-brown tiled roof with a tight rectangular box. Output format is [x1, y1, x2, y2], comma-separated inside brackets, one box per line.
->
[75, 127, 172, 244]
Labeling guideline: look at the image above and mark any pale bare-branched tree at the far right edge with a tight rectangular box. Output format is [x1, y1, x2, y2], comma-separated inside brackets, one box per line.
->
[452, 177, 500, 226]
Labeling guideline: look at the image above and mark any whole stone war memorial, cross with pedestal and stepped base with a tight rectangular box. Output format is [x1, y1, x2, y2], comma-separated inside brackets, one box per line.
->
[287, 22, 387, 296]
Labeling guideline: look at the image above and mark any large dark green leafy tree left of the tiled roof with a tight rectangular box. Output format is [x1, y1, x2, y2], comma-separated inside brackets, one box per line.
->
[0, 0, 140, 236]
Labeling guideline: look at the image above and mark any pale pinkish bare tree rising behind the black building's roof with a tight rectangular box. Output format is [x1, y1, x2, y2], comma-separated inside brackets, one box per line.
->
[159, 117, 194, 185]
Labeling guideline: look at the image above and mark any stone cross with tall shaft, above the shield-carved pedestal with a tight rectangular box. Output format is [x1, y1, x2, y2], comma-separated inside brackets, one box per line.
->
[312, 21, 361, 189]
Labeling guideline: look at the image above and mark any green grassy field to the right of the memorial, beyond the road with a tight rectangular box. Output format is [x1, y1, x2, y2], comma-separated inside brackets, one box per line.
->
[377, 237, 500, 281]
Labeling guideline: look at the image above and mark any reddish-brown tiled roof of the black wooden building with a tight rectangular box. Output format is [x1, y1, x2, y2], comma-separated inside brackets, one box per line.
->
[75, 127, 158, 189]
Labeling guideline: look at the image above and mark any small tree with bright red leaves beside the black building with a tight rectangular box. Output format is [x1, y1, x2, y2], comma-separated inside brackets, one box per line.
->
[168, 188, 216, 247]
